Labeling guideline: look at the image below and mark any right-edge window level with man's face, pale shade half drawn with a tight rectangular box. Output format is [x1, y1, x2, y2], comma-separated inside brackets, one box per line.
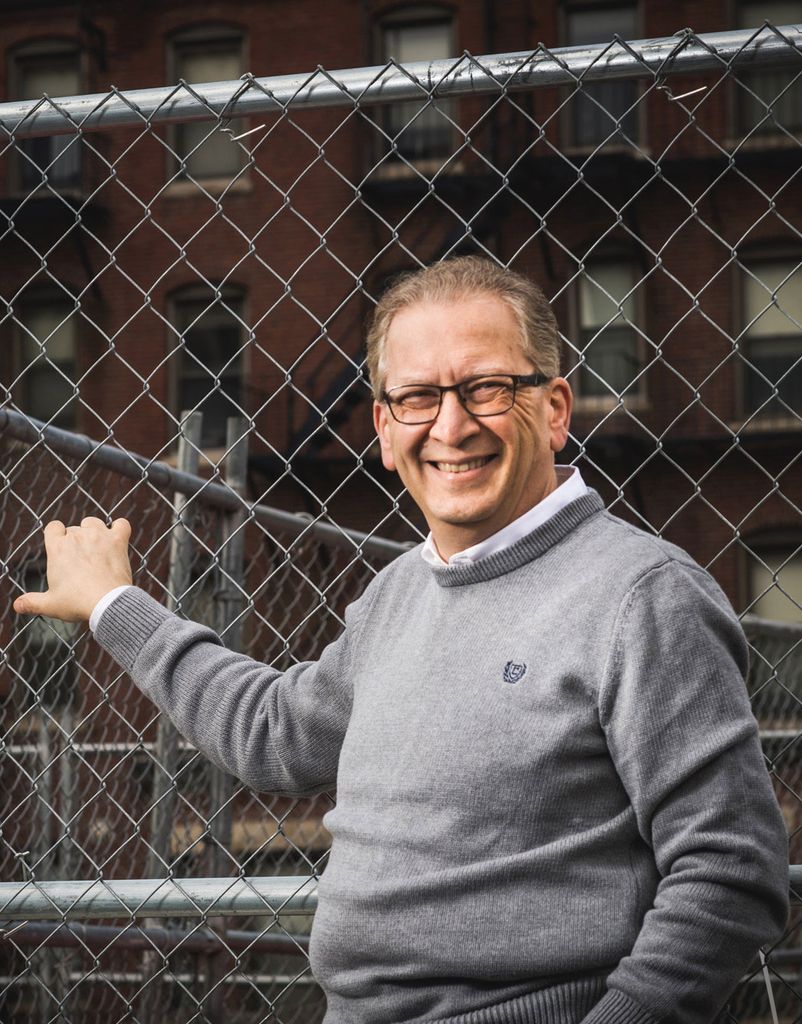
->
[742, 259, 802, 417]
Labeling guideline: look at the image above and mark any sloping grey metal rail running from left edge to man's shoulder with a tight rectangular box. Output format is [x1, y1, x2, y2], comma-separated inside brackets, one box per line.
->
[0, 409, 412, 561]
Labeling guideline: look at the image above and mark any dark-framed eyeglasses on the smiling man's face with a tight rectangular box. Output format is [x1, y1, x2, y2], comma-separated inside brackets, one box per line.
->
[382, 374, 551, 426]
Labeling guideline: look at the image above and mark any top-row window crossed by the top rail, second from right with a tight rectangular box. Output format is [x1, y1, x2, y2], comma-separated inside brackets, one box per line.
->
[565, 4, 638, 146]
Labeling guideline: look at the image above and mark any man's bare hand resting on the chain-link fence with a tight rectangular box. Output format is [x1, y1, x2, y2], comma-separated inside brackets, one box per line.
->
[14, 516, 131, 623]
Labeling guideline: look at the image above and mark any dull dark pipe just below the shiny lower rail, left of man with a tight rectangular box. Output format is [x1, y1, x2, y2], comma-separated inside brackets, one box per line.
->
[0, 921, 309, 956]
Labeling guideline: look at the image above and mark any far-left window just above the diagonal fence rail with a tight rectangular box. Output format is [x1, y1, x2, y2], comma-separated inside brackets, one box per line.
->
[17, 299, 78, 429]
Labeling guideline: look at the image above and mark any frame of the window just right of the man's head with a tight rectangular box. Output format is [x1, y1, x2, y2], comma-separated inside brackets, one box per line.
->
[565, 251, 649, 415]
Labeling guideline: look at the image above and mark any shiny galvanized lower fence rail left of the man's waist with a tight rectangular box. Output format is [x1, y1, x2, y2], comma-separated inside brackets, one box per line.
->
[0, 874, 318, 921]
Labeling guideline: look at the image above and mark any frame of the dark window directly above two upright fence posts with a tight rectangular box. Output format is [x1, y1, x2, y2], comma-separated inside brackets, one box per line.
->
[166, 283, 251, 455]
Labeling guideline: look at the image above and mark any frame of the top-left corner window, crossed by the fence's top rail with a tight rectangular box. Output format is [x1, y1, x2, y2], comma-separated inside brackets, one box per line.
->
[6, 36, 87, 198]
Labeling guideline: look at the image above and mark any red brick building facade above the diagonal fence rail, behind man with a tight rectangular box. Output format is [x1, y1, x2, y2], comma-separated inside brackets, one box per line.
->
[0, 0, 802, 617]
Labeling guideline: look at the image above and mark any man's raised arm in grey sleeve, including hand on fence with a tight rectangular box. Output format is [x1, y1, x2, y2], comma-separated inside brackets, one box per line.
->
[14, 519, 362, 796]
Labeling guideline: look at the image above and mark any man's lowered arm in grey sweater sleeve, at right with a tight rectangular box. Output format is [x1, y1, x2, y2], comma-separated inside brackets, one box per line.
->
[583, 562, 788, 1024]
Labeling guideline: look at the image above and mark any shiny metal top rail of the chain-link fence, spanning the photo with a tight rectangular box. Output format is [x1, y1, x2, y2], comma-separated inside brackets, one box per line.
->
[0, 25, 802, 138]
